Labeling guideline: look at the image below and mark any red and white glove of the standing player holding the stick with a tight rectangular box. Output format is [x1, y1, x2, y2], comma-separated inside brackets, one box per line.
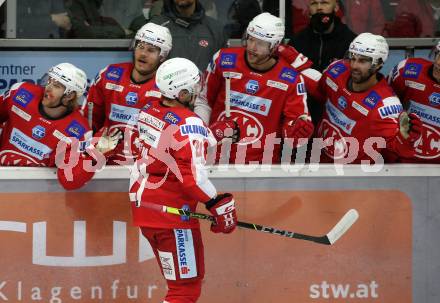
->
[206, 193, 237, 234]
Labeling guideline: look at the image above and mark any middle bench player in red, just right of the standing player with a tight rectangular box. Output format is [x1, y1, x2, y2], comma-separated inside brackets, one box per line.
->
[195, 13, 313, 164]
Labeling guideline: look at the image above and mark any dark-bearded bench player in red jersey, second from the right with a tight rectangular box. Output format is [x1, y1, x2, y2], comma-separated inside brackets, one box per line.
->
[311, 33, 421, 164]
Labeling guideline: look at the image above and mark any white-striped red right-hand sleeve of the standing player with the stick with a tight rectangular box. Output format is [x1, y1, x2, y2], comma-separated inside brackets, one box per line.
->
[173, 117, 217, 202]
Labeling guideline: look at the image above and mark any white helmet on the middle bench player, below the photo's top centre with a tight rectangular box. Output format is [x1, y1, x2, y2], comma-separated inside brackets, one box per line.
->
[246, 13, 284, 49]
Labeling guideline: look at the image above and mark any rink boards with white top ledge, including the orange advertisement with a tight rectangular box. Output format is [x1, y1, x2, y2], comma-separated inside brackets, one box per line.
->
[0, 166, 440, 303]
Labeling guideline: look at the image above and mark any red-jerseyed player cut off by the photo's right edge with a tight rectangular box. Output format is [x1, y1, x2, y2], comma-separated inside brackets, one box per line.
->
[388, 43, 440, 163]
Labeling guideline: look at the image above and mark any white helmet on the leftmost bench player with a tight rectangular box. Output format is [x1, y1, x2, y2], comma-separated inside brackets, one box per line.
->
[48, 63, 87, 97]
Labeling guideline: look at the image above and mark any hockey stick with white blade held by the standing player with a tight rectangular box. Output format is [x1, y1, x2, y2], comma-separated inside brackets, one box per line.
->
[141, 203, 359, 245]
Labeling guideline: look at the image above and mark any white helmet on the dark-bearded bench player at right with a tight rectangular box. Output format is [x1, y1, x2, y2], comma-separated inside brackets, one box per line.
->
[348, 33, 389, 66]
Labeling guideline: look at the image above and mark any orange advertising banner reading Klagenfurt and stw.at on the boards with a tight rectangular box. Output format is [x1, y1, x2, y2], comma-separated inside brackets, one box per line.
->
[0, 190, 412, 303]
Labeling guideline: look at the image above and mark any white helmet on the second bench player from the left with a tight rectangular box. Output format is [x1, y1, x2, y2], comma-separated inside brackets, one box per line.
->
[133, 22, 173, 58]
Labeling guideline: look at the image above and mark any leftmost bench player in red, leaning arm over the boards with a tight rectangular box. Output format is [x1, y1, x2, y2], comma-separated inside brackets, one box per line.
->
[0, 63, 122, 189]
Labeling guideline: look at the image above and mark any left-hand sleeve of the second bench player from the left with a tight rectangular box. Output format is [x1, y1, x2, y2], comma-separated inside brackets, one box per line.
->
[82, 68, 107, 132]
